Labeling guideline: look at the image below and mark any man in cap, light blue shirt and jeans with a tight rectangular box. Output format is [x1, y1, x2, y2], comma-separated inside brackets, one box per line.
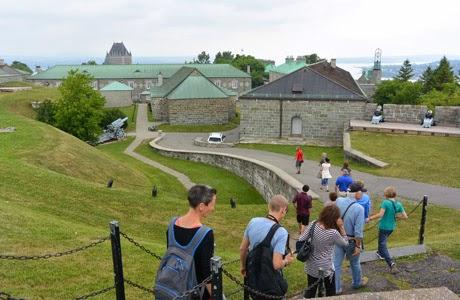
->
[334, 182, 368, 295]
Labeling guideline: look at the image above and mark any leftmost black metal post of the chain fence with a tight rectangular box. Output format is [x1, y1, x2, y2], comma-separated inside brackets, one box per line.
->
[110, 221, 125, 300]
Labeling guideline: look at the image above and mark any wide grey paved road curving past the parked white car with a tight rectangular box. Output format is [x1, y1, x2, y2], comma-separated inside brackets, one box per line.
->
[159, 132, 460, 209]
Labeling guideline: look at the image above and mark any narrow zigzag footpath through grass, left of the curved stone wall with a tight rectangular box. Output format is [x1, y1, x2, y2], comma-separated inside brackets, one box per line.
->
[124, 103, 195, 190]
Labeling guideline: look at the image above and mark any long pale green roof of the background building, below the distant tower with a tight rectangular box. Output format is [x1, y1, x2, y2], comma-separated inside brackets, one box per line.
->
[29, 64, 250, 80]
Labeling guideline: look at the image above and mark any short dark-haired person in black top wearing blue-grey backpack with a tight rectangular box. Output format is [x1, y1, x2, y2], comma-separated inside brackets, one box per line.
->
[155, 185, 217, 300]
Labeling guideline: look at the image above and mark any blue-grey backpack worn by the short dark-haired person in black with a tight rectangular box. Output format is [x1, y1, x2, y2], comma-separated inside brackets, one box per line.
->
[154, 218, 211, 300]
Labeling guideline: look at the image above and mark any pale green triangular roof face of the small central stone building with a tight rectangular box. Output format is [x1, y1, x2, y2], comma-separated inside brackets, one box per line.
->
[166, 73, 228, 100]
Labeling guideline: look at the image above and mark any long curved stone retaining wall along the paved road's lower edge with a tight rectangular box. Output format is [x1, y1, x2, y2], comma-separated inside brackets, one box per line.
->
[150, 137, 308, 201]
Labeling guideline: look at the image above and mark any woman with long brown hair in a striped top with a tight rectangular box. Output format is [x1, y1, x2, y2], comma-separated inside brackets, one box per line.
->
[299, 205, 348, 298]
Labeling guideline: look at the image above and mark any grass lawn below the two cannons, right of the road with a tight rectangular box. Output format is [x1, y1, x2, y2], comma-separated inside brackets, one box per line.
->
[351, 131, 460, 188]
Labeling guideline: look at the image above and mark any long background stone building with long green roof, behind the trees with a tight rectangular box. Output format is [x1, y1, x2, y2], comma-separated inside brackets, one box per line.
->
[28, 64, 251, 101]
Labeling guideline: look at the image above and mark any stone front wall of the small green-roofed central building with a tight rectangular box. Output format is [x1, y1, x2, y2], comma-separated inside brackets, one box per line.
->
[167, 97, 235, 125]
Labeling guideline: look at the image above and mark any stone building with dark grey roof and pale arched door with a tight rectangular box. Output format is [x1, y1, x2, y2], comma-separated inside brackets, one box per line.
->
[239, 60, 367, 145]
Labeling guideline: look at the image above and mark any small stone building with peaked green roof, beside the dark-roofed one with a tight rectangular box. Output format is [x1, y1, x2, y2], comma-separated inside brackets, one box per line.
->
[150, 67, 236, 125]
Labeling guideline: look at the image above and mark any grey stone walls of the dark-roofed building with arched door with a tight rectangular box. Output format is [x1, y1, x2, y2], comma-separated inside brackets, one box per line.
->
[240, 99, 366, 146]
